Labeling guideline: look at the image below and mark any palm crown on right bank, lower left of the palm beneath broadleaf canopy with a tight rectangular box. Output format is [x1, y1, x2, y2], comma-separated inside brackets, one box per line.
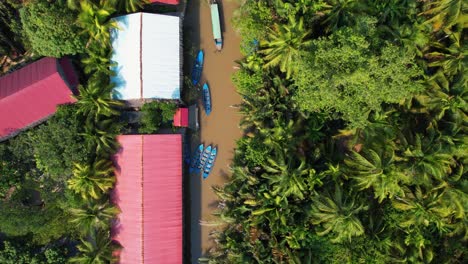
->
[310, 185, 368, 242]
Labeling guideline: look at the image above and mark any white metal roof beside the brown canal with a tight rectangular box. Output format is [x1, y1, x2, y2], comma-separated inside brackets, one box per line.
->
[111, 13, 181, 100]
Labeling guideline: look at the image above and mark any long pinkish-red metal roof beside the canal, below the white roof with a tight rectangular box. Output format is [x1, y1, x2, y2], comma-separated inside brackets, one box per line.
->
[112, 134, 182, 264]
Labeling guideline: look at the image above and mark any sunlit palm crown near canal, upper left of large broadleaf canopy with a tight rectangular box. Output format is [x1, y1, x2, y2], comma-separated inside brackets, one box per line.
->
[259, 16, 312, 78]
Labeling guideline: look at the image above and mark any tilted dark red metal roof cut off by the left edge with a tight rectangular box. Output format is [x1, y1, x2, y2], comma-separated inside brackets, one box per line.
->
[0, 58, 77, 139]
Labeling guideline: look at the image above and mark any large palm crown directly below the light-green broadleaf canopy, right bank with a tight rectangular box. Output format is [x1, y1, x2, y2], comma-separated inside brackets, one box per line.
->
[344, 149, 409, 202]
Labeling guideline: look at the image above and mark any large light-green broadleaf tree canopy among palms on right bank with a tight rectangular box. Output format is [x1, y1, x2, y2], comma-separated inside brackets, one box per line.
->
[293, 17, 423, 127]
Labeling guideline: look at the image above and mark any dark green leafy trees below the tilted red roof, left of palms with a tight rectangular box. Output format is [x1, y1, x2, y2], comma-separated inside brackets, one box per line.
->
[0, 106, 90, 244]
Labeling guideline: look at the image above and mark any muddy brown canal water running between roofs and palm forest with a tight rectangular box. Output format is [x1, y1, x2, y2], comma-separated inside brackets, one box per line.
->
[184, 0, 241, 263]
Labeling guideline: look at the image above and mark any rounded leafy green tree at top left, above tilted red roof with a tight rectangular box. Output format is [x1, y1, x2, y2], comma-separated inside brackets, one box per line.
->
[20, 0, 85, 58]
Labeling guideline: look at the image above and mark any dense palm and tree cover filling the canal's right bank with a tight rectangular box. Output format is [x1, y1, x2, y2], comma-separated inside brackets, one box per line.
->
[206, 0, 468, 263]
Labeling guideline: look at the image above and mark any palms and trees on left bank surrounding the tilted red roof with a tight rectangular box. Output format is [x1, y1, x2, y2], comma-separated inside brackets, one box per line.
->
[0, 0, 148, 263]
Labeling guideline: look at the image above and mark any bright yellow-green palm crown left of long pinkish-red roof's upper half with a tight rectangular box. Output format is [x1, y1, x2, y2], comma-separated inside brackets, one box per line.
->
[68, 159, 115, 200]
